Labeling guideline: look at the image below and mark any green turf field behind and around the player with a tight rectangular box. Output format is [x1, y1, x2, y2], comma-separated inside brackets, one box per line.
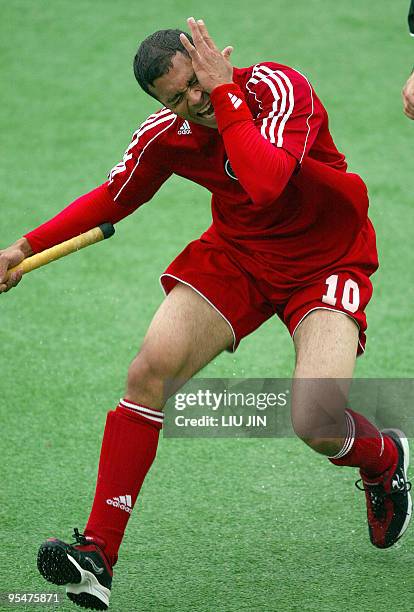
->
[0, 0, 414, 612]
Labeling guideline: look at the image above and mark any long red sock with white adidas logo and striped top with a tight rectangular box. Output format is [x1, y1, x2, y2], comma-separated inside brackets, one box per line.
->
[85, 400, 164, 566]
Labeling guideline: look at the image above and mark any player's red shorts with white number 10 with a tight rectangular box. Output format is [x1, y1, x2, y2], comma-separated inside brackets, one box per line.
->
[160, 221, 378, 354]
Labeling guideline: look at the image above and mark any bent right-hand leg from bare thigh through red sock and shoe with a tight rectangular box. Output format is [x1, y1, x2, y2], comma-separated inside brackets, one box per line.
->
[292, 310, 412, 548]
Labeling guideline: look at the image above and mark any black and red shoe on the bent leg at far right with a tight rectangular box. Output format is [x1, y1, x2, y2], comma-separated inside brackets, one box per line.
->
[355, 429, 412, 548]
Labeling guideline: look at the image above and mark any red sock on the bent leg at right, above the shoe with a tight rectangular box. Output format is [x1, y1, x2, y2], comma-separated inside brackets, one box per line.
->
[329, 409, 398, 478]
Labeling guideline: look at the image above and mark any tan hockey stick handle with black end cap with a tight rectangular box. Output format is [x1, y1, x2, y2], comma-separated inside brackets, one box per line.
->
[7, 223, 115, 278]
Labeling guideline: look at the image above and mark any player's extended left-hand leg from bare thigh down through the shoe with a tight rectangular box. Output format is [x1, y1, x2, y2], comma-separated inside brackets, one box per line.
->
[38, 284, 233, 610]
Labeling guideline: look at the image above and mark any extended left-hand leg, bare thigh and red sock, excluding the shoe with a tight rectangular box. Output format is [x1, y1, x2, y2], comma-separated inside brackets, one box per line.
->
[85, 283, 233, 548]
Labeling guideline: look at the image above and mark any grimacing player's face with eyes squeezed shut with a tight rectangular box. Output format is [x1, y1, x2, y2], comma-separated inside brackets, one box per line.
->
[149, 53, 217, 128]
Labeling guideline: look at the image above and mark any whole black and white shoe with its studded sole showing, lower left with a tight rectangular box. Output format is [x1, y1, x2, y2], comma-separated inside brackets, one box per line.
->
[37, 529, 112, 610]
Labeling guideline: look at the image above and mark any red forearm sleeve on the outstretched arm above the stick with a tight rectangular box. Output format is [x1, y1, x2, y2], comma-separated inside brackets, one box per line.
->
[25, 183, 138, 253]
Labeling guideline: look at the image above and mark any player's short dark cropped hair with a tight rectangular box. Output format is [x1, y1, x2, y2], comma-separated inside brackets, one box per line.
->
[134, 30, 193, 98]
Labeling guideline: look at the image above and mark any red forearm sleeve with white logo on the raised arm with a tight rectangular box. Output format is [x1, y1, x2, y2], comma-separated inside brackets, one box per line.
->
[211, 83, 297, 206]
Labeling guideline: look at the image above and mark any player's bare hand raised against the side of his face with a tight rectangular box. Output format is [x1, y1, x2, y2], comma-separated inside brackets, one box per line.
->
[180, 17, 233, 93]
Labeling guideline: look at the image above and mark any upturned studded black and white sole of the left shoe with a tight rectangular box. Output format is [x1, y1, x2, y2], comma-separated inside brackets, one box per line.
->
[37, 542, 111, 610]
